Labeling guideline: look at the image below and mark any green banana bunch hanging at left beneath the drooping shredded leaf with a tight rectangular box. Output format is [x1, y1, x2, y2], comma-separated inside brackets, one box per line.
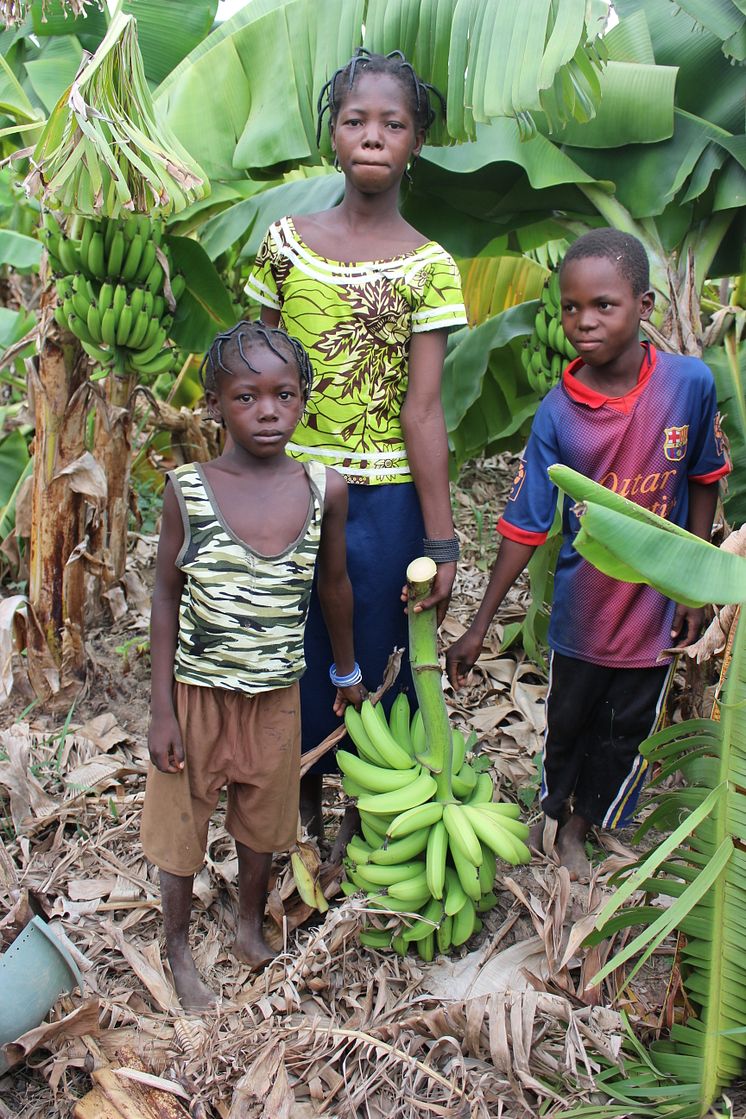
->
[43, 213, 186, 384]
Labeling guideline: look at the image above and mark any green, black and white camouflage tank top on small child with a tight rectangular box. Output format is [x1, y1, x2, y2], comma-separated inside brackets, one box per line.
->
[168, 462, 327, 695]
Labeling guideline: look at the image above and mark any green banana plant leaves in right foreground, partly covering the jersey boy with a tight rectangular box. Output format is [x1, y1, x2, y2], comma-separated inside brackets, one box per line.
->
[549, 467, 746, 1119]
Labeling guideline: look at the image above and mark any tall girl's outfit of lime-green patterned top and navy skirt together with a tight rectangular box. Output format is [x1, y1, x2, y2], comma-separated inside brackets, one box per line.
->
[246, 217, 466, 772]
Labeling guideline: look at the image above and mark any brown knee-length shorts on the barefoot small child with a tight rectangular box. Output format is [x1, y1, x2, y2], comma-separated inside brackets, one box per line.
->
[140, 680, 301, 877]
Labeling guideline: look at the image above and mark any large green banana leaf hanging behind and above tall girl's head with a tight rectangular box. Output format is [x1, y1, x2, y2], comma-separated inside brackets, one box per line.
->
[157, 0, 601, 179]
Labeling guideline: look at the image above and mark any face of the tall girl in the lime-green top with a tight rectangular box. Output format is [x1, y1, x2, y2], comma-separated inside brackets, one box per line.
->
[331, 72, 425, 194]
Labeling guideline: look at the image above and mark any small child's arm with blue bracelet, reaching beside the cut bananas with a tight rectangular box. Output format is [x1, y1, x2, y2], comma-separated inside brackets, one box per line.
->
[317, 470, 366, 715]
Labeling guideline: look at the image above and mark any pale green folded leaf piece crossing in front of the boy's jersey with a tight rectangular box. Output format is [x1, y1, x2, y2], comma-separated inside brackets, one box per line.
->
[549, 464, 746, 606]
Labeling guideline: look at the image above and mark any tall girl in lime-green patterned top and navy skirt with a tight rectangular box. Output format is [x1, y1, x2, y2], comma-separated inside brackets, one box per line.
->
[246, 49, 466, 848]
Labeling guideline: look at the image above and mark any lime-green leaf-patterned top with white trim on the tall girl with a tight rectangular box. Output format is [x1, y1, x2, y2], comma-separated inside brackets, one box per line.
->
[246, 217, 466, 486]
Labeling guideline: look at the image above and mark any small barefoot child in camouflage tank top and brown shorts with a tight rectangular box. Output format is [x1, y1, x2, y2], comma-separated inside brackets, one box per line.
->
[141, 322, 365, 1009]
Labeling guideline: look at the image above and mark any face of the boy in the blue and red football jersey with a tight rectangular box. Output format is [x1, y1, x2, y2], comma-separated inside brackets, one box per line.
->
[560, 256, 654, 366]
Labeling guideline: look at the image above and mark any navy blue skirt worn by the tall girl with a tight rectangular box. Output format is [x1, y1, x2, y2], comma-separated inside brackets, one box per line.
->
[301, 482, 425, 773]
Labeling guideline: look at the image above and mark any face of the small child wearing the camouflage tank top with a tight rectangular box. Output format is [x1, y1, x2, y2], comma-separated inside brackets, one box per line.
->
[205, 344, 305, 459]
